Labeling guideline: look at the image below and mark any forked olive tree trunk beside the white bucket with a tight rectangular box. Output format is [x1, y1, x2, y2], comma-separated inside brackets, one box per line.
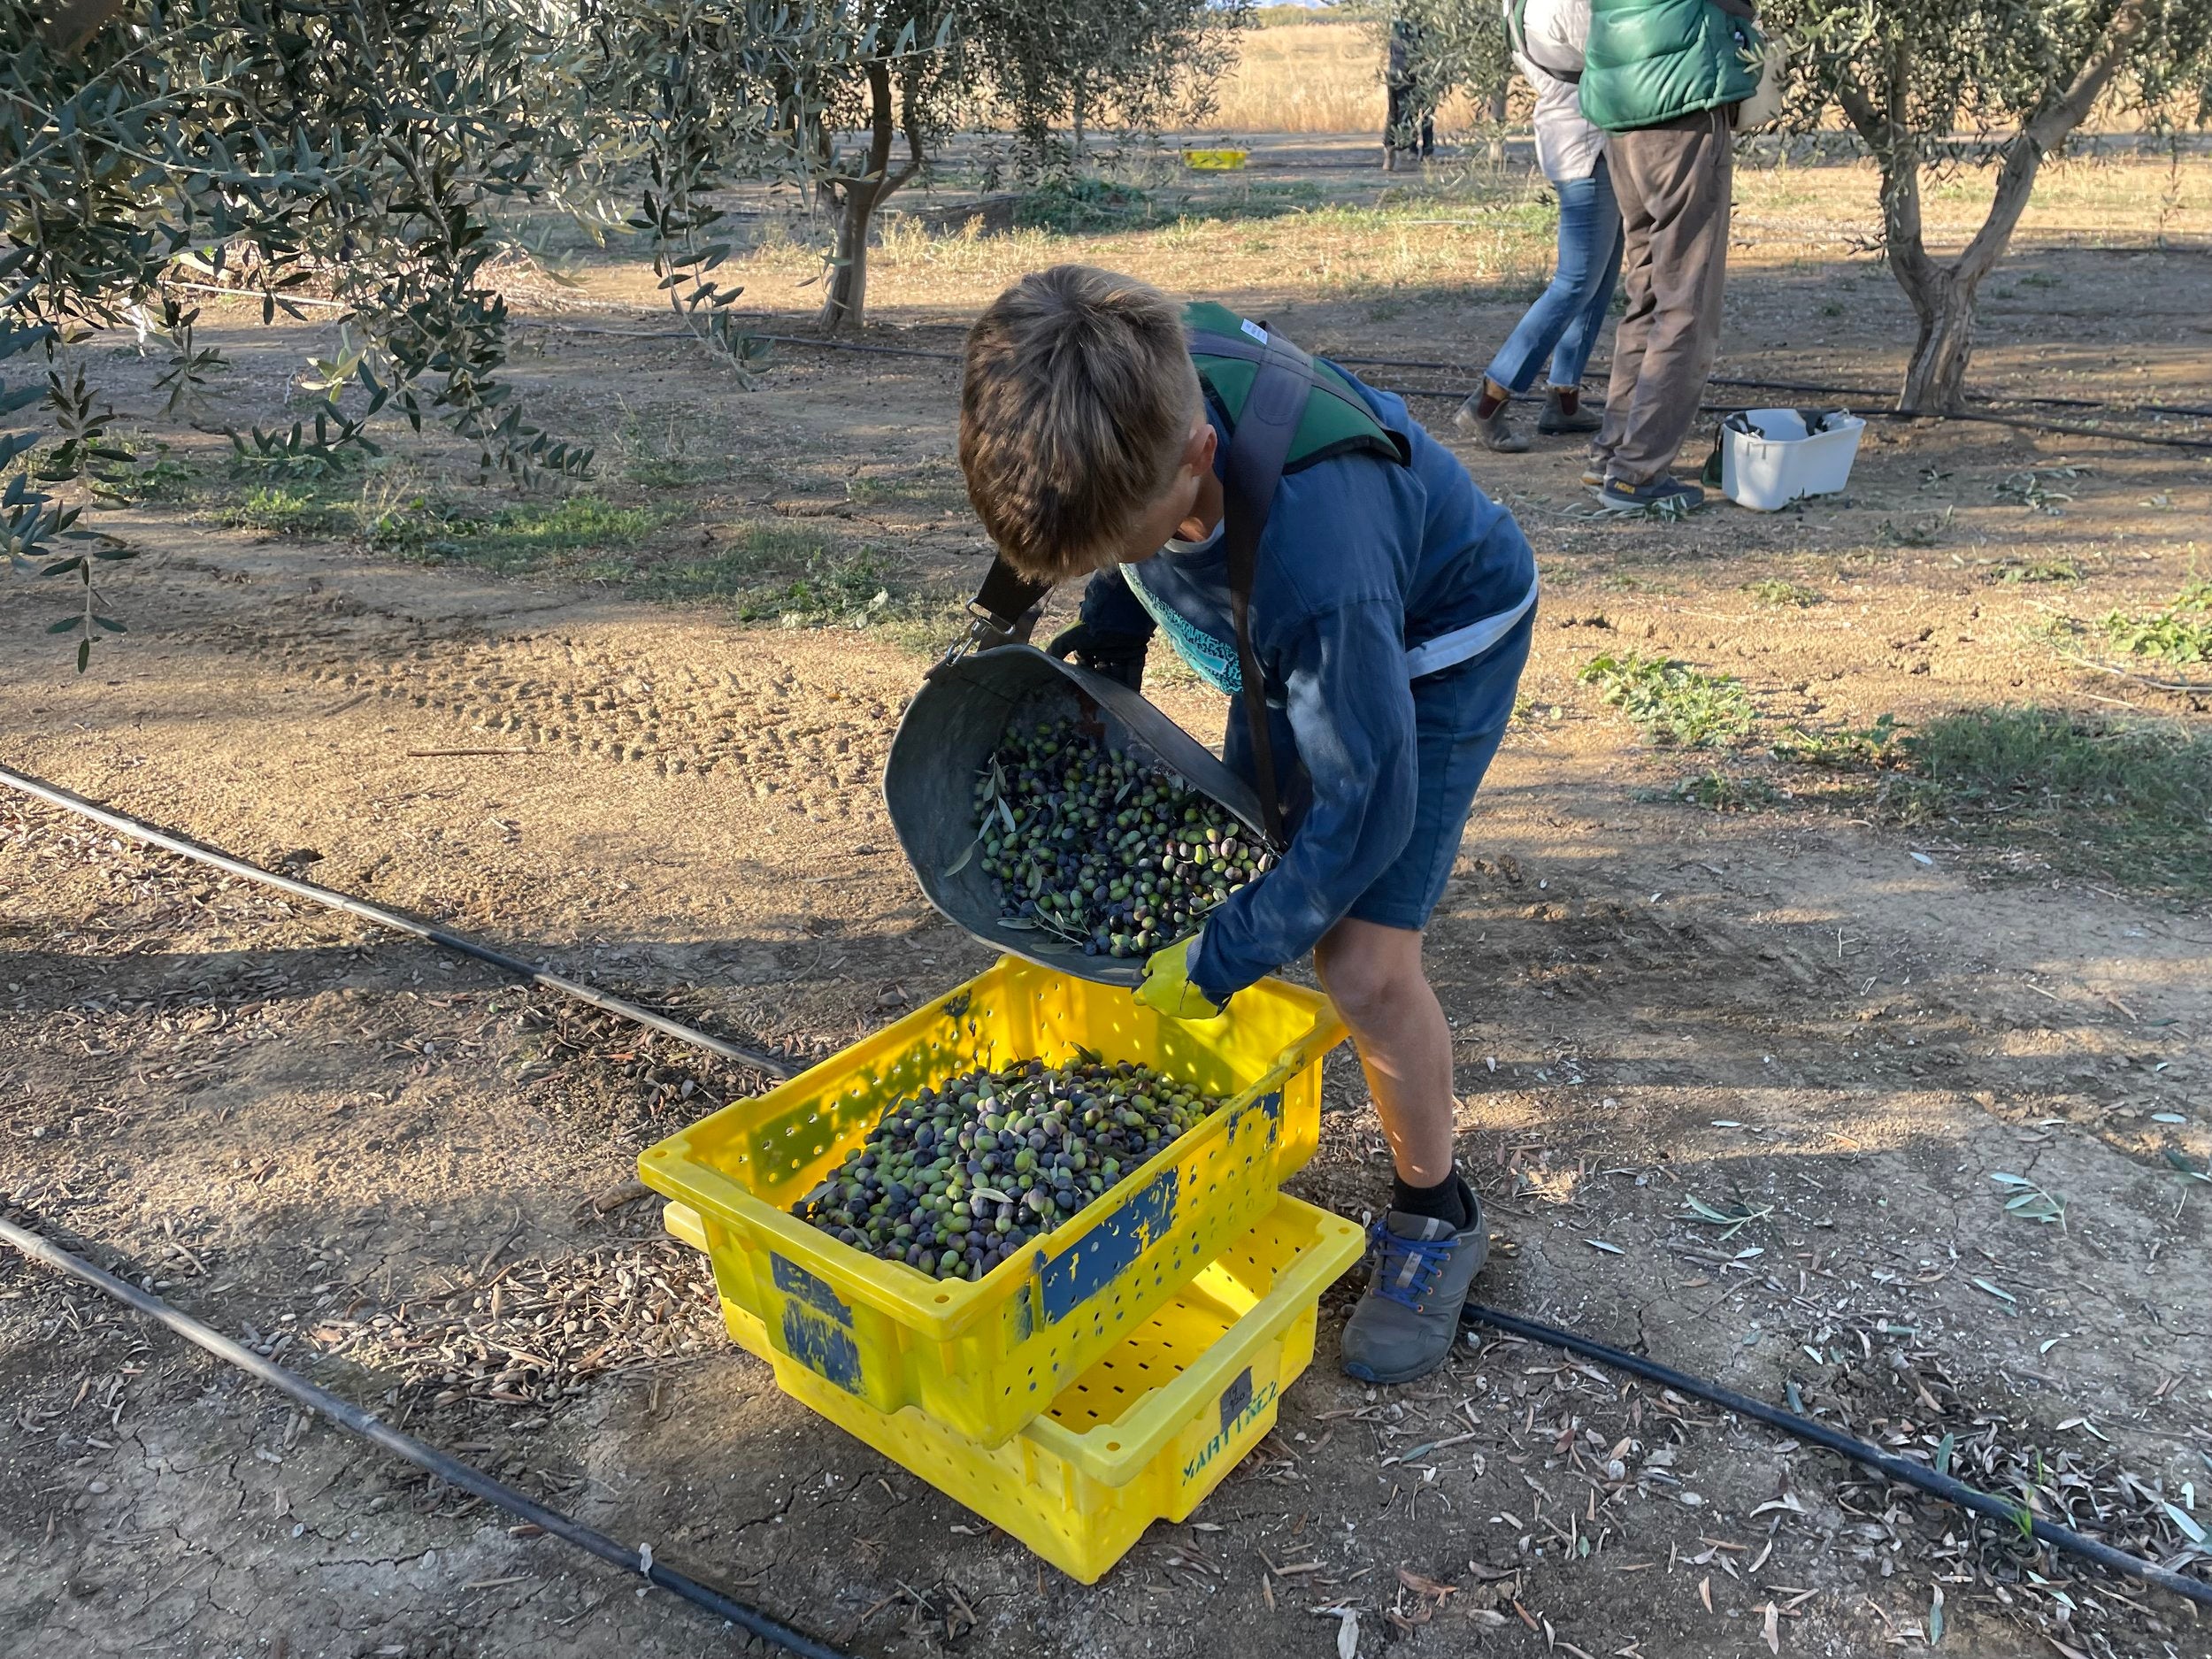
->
[1839, 0, 2150, 414]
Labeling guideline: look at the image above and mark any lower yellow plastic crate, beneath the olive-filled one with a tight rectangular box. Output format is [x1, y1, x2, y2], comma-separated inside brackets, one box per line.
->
[666, 1197, 1365, 1584]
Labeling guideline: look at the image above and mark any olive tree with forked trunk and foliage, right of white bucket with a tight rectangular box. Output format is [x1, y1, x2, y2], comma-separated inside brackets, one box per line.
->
[1761, 0, 2212, 414]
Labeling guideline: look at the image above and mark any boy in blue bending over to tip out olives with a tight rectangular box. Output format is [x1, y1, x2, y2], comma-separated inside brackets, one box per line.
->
[960, 265, 1535, 1383]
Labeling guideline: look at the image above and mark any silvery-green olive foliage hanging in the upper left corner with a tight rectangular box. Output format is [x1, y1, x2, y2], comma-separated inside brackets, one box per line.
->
[0, 0, 849, 668]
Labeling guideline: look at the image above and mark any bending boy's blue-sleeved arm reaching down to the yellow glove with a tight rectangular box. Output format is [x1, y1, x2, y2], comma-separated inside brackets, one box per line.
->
[1190, 602, 1418, 1004]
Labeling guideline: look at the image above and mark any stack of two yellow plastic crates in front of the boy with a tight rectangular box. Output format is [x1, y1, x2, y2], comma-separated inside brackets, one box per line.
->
[640, 958, 1361, 1582]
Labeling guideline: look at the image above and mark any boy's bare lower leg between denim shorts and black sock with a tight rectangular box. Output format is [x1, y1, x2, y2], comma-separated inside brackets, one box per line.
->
[1314, 918, 1454, 1186]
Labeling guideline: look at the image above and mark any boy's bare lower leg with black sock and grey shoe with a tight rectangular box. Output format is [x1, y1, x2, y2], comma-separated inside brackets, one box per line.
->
[1314, 920, 1489, 1383]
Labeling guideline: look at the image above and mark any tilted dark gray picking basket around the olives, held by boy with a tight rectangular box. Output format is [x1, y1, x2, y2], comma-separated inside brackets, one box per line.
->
[883, 646, 1265, 987]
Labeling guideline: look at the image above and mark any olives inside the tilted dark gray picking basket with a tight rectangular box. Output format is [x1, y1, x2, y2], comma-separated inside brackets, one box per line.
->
[976, 719, 1274, 956]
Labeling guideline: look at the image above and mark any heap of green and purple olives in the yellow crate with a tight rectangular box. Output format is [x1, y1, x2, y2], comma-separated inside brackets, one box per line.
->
[795, 1060, 1221, 1279]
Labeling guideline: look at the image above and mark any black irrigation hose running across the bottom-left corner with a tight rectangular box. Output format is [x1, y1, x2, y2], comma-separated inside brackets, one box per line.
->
[0, 1217, 849, 1659]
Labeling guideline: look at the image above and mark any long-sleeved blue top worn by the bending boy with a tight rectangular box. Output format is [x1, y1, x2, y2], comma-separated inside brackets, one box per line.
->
[1082, 369, 1535, 1002]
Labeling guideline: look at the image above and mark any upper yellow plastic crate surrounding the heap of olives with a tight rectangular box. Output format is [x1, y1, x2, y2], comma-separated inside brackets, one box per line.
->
[637, 956, 1345, 1447]
